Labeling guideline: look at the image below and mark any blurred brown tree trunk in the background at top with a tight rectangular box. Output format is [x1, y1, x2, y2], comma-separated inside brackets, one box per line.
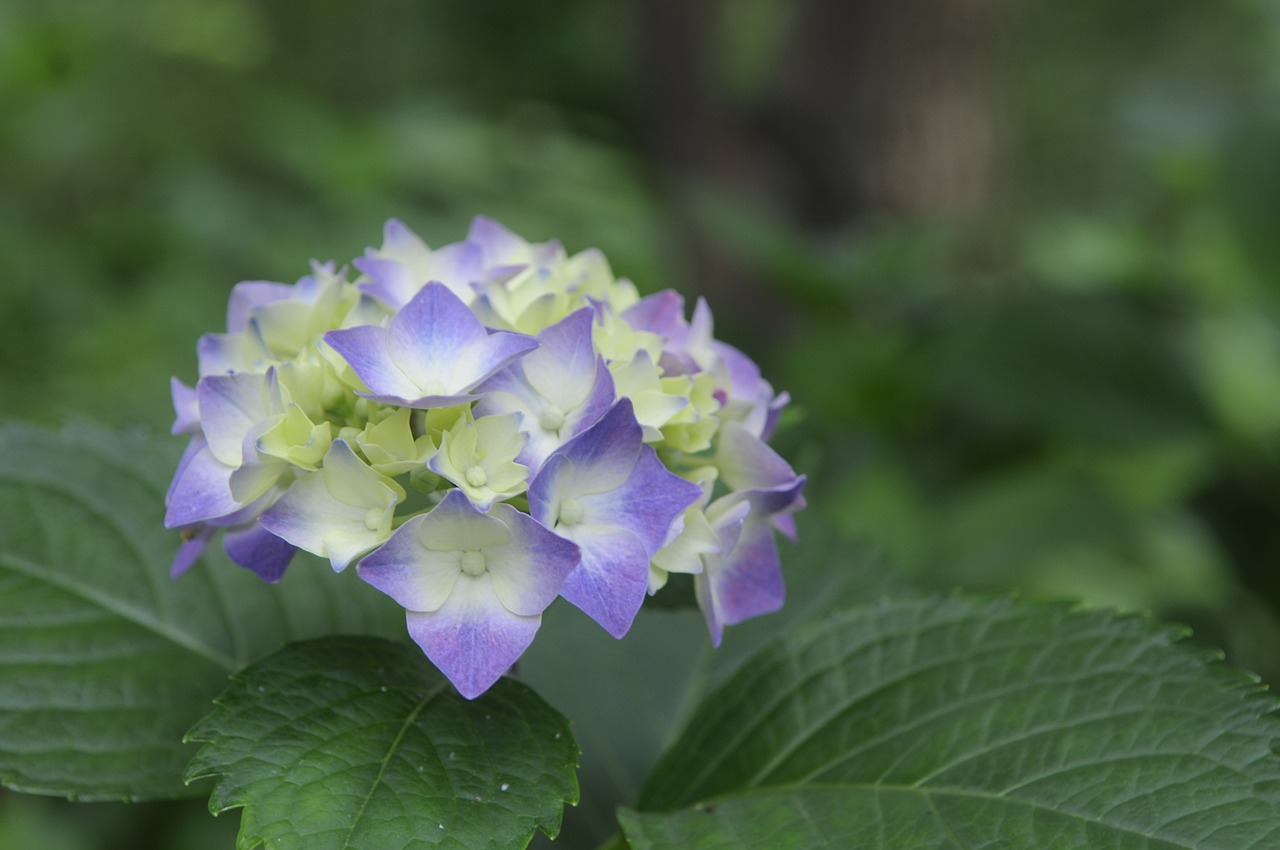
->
[634, 0, 1005, 307]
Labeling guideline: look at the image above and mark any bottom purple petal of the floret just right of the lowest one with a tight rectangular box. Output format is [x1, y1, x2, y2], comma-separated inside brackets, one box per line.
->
[561, 525, 649, 638]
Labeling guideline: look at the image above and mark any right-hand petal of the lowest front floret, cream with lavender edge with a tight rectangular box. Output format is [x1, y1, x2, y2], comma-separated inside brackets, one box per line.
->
[484, 504, 581, 617]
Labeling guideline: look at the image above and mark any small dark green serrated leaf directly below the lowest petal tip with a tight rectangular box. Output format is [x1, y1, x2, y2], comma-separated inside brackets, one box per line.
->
[187, 638, 579, 850]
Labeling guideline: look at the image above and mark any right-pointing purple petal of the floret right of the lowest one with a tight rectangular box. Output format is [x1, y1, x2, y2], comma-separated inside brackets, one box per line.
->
[582, 445, 703, 556]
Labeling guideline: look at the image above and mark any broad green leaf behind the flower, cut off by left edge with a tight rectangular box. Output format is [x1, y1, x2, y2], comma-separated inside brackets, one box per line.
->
[0, 425, 404, 799]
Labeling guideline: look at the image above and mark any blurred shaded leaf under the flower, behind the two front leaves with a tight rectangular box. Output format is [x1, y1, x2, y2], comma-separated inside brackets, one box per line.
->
[520, 524, 904, 849]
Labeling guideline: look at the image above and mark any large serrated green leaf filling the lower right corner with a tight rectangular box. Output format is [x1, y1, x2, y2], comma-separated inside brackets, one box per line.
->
[621, 598, 1280, 850]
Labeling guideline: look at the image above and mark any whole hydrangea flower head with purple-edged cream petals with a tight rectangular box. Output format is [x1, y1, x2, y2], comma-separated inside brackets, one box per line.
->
[165, 218, 804, 698]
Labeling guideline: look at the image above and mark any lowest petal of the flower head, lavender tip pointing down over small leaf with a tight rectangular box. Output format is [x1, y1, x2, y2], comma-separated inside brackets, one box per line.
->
[407, 575, 541, 699]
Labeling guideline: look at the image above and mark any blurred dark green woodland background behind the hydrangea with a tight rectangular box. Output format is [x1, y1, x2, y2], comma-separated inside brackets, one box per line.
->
[0, 0, 1280, 850]
